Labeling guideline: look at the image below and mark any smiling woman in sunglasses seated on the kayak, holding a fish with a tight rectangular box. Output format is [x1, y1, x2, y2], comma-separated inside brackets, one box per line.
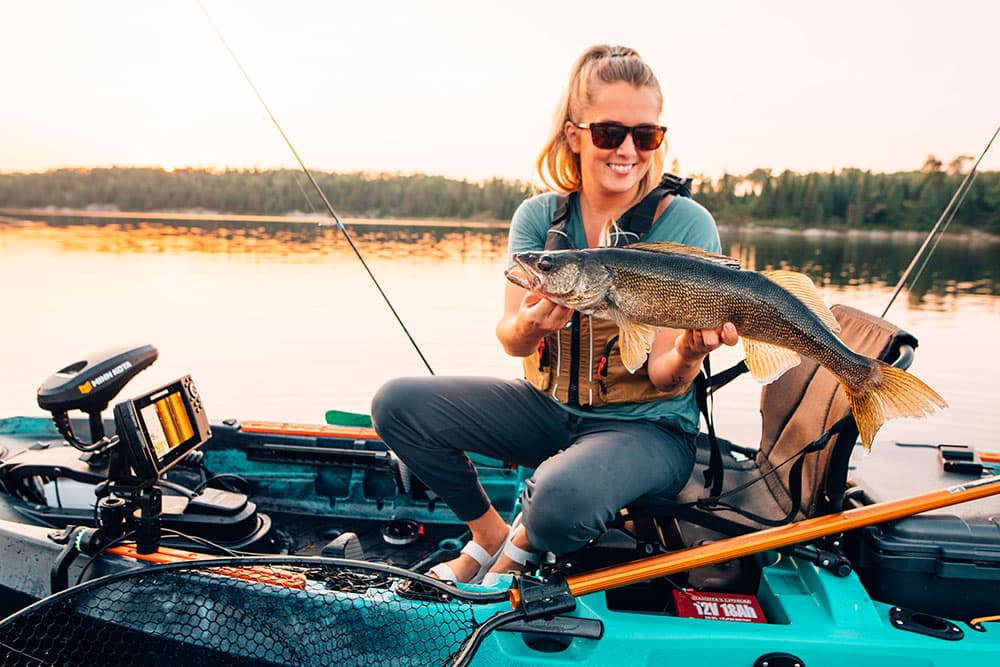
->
[372, 46, 738, 583]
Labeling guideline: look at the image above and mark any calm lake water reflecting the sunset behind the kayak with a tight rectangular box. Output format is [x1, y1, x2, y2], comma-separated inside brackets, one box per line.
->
[0, 221, 1000, 449]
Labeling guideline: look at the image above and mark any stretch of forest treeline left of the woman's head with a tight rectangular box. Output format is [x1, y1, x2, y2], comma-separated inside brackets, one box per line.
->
[0, 167, 530, 220]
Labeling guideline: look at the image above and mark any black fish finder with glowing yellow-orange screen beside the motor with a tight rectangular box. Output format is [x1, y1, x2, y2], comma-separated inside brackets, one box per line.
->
[115, 375, 212, 487]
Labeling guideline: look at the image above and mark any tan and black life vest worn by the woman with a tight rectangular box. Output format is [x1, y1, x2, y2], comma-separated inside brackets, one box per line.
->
[524, 174, 691, 408]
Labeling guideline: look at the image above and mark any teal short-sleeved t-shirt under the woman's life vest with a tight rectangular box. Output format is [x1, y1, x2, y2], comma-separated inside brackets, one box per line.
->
[507, 192, 722, 433]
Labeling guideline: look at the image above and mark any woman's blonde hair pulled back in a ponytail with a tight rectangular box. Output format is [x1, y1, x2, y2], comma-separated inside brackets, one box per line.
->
[535, 44, 667, 200]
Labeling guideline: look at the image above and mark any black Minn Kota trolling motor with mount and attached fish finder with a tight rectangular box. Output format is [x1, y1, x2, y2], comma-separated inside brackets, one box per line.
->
[0, 345, 271, 592]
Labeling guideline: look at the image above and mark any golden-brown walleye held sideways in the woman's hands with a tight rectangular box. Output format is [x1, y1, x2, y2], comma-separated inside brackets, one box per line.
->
[505, 242, 947, 449]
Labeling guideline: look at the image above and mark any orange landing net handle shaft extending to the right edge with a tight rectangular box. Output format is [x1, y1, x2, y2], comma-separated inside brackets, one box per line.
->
[510, 475, 1000, 609]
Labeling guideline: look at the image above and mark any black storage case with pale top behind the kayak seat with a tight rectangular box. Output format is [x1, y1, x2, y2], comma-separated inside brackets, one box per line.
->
[848, 443, 1000, 620]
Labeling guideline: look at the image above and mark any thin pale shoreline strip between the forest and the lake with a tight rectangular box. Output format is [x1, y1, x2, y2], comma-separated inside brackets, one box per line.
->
[0, 207, 1000, 243]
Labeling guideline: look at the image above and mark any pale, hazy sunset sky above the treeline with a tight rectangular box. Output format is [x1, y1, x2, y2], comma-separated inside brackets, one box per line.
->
[0, 0, 1000, 182]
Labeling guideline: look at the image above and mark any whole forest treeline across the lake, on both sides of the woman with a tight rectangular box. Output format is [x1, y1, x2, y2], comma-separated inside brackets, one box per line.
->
[0, 156, 1000, 234]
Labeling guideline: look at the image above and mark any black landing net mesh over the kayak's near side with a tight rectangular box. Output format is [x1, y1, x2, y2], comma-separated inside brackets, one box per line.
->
[0, 559, 496, 667]
